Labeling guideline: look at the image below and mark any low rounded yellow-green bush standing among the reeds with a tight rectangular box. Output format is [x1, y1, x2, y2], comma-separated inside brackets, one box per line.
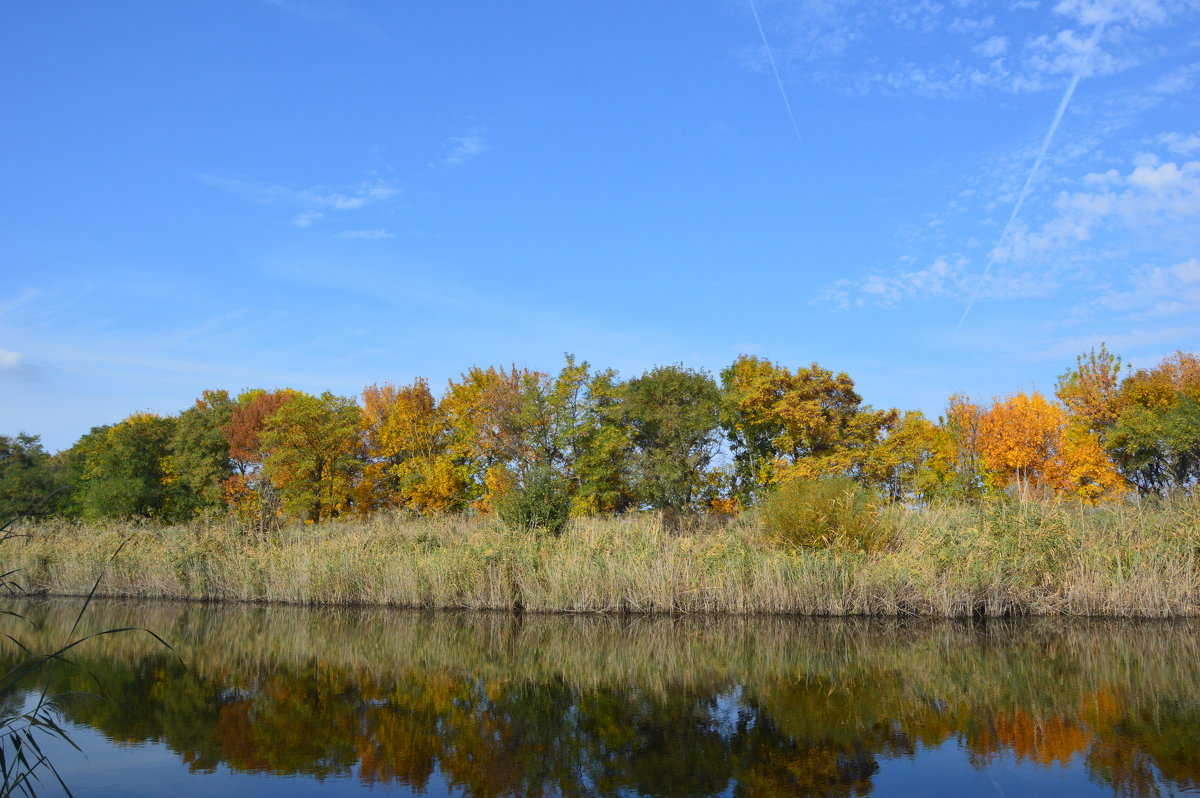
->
[758, 476, 889, 551]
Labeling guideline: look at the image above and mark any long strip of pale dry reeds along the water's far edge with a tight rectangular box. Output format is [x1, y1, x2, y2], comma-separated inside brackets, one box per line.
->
[4, 498, 1200, 618]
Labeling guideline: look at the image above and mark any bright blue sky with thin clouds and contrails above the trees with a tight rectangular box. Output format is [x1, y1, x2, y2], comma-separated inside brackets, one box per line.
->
[0, 0, 1200, 449]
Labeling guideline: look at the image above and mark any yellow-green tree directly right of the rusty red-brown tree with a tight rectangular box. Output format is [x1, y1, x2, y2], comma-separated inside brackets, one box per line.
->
[260, 391, 361, 522]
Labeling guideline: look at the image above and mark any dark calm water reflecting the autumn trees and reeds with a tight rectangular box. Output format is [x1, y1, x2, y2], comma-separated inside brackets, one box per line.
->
[8, 600, 1200, 798]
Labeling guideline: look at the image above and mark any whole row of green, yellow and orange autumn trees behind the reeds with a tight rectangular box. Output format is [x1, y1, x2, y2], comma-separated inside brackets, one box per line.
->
[0, 346, 1200, 528]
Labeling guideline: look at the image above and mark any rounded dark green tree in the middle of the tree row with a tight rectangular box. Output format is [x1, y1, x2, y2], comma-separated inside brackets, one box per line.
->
[623, 365, 721, 510]
